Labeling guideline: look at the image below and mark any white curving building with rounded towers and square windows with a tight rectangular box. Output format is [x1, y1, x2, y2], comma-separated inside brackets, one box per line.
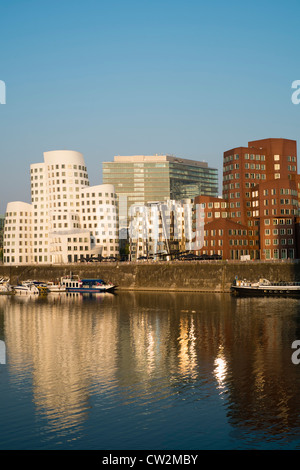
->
[3, 150, 119, 265]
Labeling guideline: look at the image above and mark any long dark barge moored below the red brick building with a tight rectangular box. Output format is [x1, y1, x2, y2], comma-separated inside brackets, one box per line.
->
[231, 279, 300, 297]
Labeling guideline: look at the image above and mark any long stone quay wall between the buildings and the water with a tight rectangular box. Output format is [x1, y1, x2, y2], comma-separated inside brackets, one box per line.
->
[0, 261, 300, 292]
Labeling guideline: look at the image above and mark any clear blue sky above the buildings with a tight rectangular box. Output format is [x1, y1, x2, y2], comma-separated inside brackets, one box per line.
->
[0, 0, 300, 214]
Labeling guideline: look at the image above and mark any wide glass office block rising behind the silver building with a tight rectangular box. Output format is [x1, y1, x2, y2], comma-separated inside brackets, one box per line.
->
[103, 155, 218, 209]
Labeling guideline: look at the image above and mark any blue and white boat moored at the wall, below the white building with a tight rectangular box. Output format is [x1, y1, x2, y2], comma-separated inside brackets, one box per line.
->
[61, 276, 116, 294]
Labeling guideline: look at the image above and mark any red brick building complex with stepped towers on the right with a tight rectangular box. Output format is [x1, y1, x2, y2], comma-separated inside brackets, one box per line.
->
[194, 139, 300, 259]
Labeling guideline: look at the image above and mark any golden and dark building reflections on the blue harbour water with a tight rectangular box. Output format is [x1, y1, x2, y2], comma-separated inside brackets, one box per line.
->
[0, 292, 300, 442]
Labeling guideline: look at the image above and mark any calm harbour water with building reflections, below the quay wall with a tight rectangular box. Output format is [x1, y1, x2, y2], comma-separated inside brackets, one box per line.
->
[0, 293, 300, 450]
